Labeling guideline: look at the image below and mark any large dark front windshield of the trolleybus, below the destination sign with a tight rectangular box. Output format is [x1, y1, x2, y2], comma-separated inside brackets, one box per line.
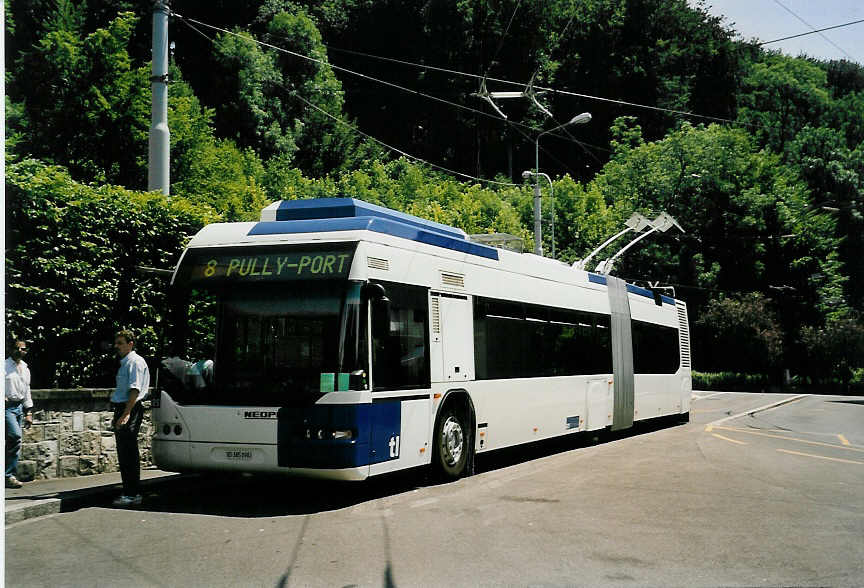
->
[162, 280, 368, 406]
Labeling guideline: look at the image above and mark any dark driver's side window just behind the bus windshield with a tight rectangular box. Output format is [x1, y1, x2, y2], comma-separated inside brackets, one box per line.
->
[372, 282, 429, 390]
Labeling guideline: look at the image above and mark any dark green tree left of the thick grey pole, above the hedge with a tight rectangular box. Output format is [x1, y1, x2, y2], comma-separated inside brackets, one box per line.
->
[12, 11, 149, 187]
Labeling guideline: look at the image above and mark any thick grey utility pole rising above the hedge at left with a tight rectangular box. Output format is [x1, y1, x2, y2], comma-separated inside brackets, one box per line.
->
[147, 0, 171, 196]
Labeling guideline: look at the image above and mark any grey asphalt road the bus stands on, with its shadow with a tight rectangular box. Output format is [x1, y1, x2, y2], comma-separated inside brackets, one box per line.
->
[5, 392, 864, 587]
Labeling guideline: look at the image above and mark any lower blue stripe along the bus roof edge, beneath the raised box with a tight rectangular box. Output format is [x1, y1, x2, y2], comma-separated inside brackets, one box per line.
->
[248, 216, 498, 261]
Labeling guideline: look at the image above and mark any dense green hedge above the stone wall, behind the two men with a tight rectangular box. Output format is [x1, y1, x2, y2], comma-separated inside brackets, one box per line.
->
[6, 160, 219, 387]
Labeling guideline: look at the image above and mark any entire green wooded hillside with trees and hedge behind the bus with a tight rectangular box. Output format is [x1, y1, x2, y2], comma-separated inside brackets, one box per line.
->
[5, 0, 864, 384]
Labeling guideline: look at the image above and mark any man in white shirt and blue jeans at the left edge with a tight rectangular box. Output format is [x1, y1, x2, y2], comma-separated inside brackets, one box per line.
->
[4, 339, 33, 488]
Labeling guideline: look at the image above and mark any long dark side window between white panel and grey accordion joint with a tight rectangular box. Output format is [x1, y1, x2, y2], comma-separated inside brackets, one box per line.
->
[474, 297, 612, 380]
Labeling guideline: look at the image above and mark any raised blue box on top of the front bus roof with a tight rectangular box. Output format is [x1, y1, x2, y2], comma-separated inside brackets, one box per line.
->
[276, 198, 468, 240]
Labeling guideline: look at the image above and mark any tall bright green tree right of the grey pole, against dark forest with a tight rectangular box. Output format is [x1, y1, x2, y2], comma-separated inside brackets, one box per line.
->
[216, 9, 374, 175]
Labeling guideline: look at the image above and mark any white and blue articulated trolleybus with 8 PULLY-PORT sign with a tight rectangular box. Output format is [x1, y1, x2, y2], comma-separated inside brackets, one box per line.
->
[152, 198, 691, 480]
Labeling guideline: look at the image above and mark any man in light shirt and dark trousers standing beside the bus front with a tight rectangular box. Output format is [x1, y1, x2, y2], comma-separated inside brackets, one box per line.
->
[111, 330, 150, 506]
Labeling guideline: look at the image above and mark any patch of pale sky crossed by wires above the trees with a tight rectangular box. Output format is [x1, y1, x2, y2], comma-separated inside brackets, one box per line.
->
[689, 0, 864, 64]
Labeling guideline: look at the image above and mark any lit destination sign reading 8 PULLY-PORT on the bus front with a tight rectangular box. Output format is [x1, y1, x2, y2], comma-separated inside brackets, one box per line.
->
[178, 247, 353, 283]
